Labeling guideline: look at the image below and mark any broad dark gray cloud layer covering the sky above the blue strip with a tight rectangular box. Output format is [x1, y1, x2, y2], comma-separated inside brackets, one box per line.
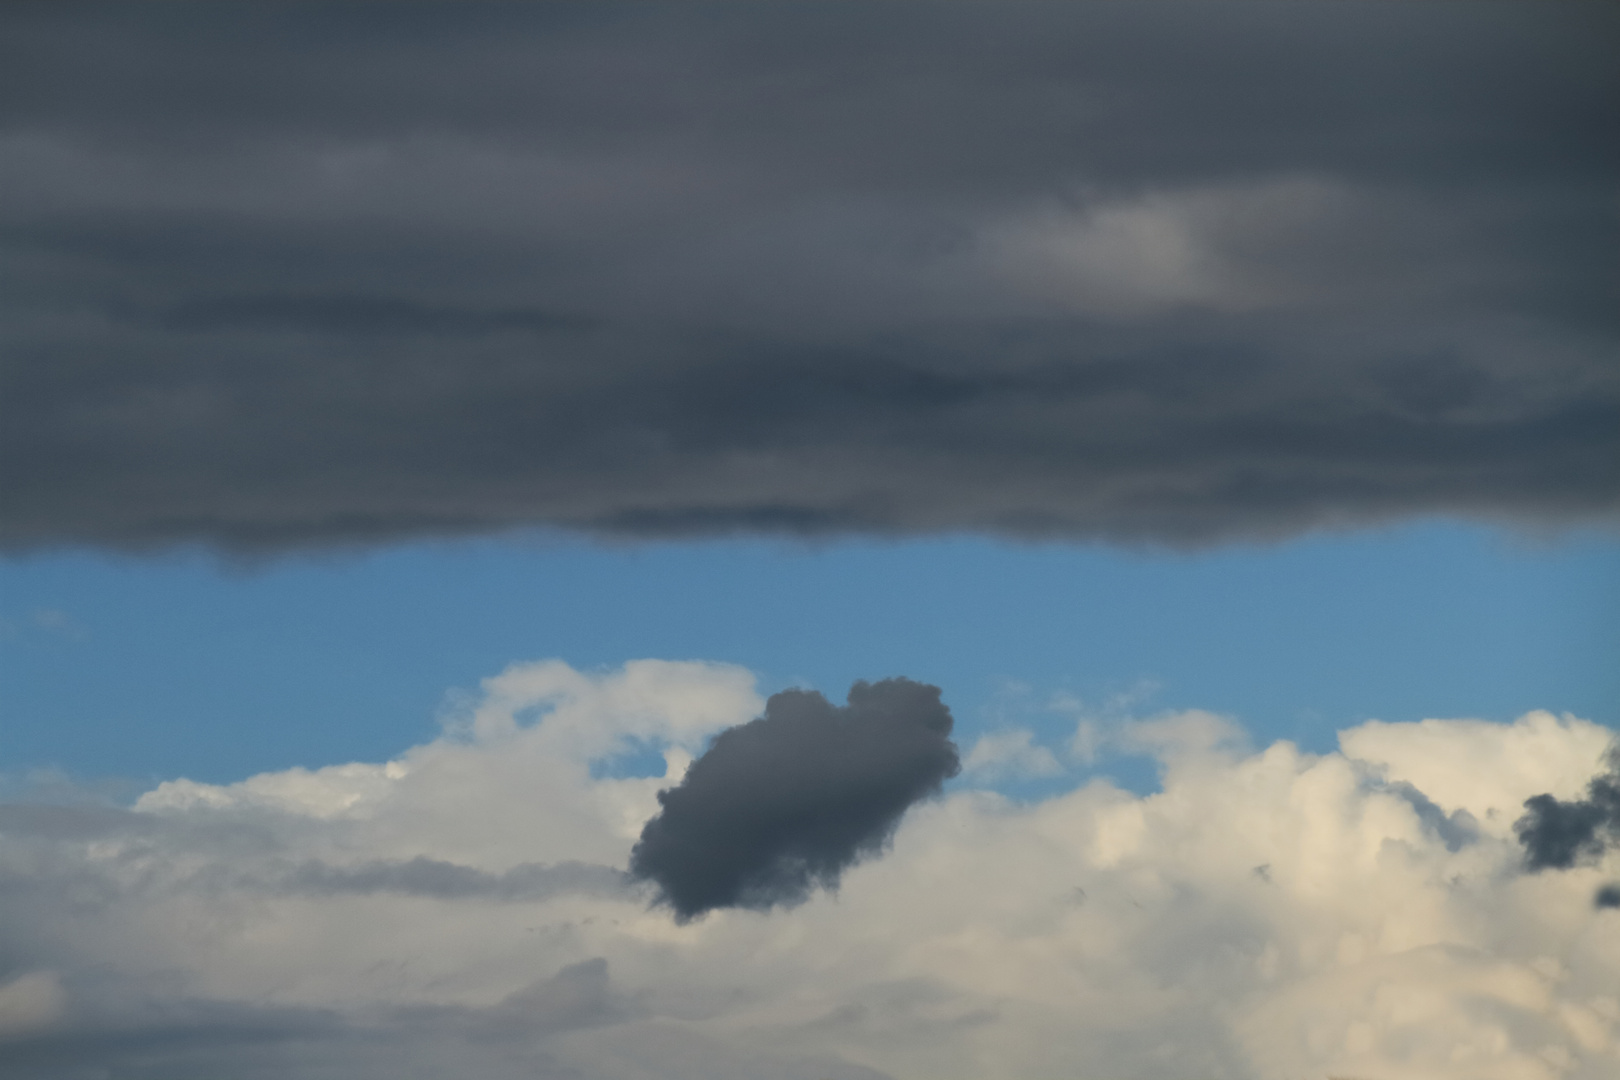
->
[0, 3, 1620, 551]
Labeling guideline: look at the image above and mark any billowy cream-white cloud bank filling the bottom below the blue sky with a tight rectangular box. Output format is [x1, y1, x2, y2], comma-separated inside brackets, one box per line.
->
[0, 661, 1620, 1080]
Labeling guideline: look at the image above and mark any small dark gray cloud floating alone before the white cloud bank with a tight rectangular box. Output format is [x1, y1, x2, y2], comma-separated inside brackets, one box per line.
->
[630, 678, 961, 920]
